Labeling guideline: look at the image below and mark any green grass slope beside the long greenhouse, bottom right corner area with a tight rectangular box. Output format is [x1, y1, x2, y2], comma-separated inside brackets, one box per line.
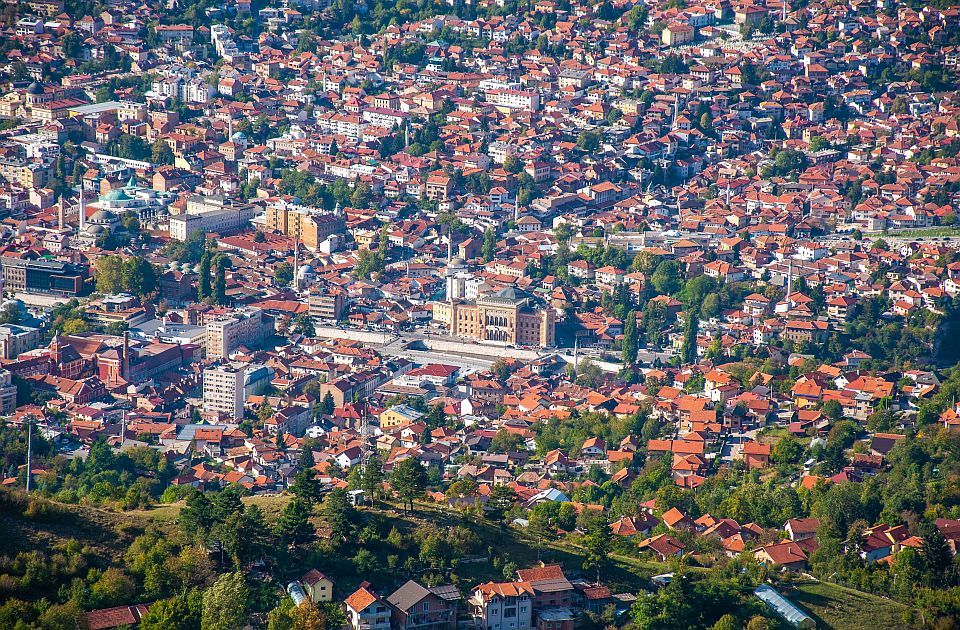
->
[781, 582, 909, 630]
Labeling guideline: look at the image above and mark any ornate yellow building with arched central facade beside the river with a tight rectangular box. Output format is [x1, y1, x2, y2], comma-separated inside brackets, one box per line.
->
[433, 288, 556, 347]
